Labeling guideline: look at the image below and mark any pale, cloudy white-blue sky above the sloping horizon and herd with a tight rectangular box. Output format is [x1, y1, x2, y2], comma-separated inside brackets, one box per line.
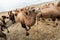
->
[0, 0, 55, 12]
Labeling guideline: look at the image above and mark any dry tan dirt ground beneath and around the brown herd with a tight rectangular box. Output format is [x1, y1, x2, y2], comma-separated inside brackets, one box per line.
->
[0, 12, 60, 40]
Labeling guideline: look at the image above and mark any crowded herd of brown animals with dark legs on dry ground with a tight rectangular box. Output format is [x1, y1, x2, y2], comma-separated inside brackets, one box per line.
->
[0, 1, 60, 40]
